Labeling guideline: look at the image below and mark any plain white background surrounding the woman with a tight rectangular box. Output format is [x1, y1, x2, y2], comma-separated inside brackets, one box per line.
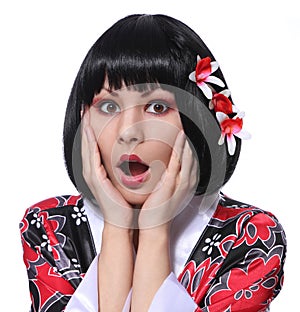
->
[0, 0, 300, 312]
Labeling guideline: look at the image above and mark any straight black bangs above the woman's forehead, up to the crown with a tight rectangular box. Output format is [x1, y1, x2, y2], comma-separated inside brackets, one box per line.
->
[82, 15, 186, 103]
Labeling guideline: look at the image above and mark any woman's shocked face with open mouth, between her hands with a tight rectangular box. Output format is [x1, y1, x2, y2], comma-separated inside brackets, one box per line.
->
[90, 83, 182, 205]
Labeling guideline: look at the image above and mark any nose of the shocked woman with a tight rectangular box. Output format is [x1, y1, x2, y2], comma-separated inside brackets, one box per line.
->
[118, 108, 144, 145]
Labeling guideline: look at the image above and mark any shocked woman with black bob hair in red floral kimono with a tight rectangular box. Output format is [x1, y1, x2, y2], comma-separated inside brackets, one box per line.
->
[20, 15, 286, 311]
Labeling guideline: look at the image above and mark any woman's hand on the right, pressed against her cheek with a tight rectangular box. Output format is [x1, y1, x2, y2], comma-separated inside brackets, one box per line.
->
[139, 130, 199, 230]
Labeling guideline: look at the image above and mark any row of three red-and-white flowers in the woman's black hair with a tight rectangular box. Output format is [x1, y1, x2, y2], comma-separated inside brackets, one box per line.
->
[189, 55, 251, 155]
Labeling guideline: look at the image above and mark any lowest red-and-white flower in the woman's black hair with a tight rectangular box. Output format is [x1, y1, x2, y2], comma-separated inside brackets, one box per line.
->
[216, 112, 251, 155]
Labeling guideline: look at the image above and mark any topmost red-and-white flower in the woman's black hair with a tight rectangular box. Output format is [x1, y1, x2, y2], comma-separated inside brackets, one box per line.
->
[189, 55, 225, 100]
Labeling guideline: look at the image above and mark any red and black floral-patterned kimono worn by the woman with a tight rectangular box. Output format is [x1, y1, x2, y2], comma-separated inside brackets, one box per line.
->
[20, 193, 286, 312]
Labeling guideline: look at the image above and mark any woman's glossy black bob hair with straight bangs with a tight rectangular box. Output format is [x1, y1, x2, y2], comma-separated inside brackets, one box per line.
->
[63, 15, 241, 198]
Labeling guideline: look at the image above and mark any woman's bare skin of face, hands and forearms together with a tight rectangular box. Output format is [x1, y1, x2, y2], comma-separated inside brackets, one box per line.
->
[82, 86, 197, 312]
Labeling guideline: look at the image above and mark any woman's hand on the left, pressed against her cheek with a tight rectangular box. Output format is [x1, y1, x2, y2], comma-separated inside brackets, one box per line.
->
[81, 106, 134, 228]
